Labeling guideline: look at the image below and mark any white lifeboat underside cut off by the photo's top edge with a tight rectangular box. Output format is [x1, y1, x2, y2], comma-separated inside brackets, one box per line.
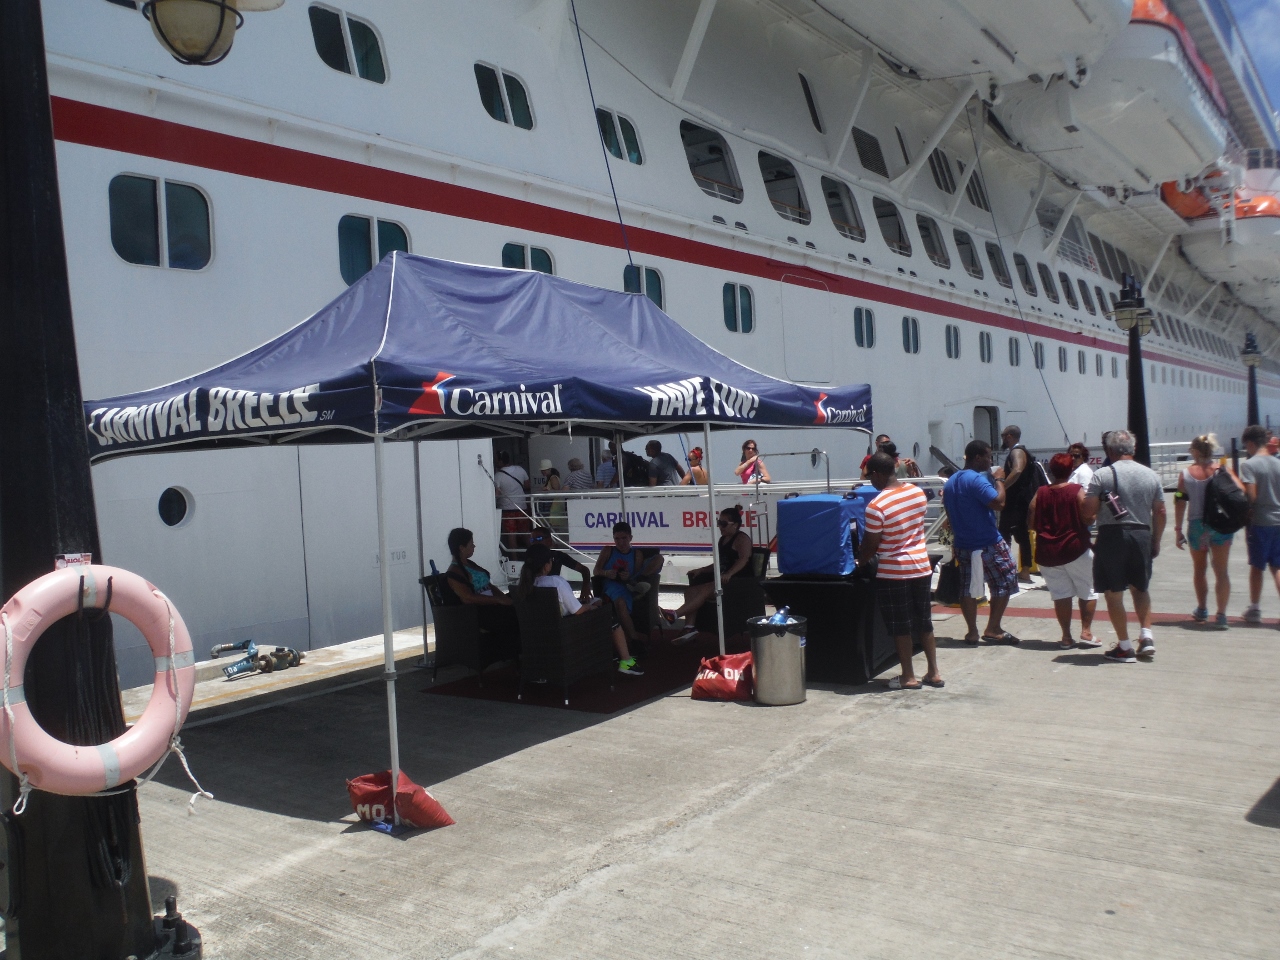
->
[822, 0, 1130, 86]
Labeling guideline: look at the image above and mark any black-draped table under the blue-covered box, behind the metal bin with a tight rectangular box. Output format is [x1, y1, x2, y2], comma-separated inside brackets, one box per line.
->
[760, 576, 897, 685]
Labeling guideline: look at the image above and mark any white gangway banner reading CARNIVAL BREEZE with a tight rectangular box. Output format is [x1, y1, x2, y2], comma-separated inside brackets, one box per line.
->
[566, 486, 777, 553]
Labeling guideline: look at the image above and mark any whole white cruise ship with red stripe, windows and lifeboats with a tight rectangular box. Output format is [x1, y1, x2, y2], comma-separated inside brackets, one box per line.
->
[44, 0, 1280, 684]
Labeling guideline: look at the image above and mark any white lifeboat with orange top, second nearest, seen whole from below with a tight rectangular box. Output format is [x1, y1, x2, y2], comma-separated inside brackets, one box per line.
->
[996, 0, 1228, 191]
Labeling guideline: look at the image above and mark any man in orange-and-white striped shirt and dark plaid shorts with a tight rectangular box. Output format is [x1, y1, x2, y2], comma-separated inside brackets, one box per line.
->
[858, 453, 943, 690]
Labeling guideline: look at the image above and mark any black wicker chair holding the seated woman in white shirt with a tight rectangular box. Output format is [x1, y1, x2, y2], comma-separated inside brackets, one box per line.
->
[516, 586, 614, 707]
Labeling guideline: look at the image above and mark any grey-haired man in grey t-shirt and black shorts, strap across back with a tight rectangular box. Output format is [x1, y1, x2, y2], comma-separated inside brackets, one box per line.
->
[1080, 430, 1165, 663]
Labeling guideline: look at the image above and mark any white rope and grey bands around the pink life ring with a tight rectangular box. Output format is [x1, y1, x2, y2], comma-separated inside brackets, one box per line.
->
[0, 577, 214, 817]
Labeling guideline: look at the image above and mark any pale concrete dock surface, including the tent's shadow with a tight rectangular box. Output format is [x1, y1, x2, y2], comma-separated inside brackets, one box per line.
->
[140, 532, 1280, 960]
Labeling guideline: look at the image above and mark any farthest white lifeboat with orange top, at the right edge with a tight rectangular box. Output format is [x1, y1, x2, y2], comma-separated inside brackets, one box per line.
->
[1183, 195, 1280, 317]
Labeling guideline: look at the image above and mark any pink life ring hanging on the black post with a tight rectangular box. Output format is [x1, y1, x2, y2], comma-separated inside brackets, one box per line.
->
[0, 564, 196, 796]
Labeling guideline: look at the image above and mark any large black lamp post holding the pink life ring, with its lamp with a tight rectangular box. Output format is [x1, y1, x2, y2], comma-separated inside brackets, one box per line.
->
[0, 0, 283, 960]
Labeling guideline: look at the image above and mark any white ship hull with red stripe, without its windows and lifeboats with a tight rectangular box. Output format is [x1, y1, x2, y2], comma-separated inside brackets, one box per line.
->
[35, 0, 1280, 681]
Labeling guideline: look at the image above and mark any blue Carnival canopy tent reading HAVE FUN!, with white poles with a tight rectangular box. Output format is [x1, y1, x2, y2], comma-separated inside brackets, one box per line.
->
[84, 252, 872, 819]
